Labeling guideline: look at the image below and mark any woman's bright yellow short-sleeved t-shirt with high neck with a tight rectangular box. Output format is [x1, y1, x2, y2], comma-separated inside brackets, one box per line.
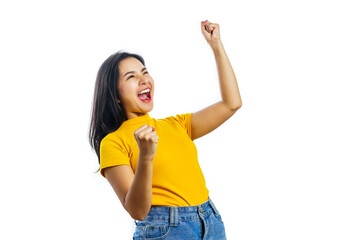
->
[100, 113, 209, 206]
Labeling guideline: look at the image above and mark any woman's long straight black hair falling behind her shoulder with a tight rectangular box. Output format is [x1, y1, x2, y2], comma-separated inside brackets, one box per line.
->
[89, 50, 145, 171]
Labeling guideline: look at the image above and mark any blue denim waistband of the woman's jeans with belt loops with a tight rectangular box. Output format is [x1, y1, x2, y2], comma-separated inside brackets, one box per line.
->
[134, 197, 219, 226]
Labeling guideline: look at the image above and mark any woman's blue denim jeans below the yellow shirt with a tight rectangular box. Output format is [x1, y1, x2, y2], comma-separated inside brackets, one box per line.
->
[133, 198, 226, 240]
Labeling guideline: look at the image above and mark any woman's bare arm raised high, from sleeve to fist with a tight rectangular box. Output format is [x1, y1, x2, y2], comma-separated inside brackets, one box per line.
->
[191, 21, 242, 140]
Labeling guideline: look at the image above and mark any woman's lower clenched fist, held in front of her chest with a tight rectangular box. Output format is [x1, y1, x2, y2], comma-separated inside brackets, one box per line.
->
[134, 125, 159, 161]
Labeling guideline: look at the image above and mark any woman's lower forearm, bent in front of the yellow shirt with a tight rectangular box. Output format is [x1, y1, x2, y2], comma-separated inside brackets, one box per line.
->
[125, 157, 153, 220]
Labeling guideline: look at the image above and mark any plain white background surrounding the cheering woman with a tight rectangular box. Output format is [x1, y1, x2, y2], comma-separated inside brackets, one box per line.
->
[0, 0, 360, 240]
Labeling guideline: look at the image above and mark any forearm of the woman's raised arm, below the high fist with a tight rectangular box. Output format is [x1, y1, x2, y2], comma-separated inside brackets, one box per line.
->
[211, 40, 242, 109]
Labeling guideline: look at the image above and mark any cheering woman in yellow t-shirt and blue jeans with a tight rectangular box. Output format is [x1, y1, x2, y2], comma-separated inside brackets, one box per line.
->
[89, 20, 242, 240]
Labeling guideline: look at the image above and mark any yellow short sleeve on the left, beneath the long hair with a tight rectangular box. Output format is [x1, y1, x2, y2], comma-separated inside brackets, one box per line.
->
[100, 137, 130, 177]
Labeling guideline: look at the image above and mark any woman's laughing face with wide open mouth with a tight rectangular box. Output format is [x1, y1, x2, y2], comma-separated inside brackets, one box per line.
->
[117, 57, 154, 119]
